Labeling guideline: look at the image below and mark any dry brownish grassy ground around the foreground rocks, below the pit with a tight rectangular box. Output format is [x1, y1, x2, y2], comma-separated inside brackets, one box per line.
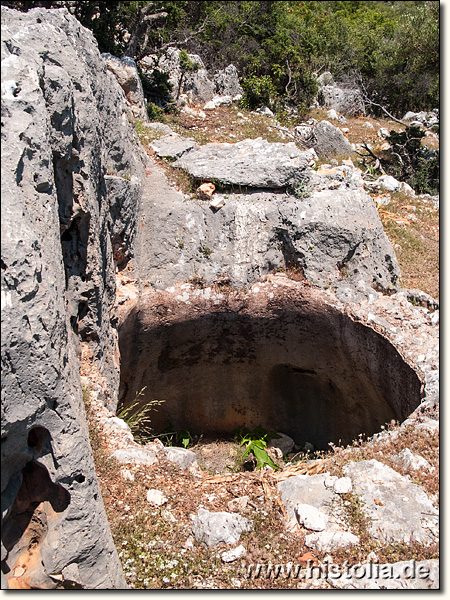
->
[81, 380, 439, 589]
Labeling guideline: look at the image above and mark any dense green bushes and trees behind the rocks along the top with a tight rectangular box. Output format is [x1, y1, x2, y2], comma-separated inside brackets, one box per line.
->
[2, 0, 439, 116]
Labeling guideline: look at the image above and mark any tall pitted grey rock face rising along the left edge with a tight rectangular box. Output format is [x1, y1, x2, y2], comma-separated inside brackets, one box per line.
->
[2, 7, 148, 589]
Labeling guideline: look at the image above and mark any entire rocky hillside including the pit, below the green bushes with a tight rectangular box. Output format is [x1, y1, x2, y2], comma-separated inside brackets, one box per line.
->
[2, 8, 439, 589]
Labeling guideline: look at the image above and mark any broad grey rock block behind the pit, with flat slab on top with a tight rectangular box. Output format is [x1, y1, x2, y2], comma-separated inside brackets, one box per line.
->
[137, 148, 400, 289]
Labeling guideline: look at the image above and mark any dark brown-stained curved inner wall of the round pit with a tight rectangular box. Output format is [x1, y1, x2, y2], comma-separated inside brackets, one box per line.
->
[119, 288, 422, 449]
